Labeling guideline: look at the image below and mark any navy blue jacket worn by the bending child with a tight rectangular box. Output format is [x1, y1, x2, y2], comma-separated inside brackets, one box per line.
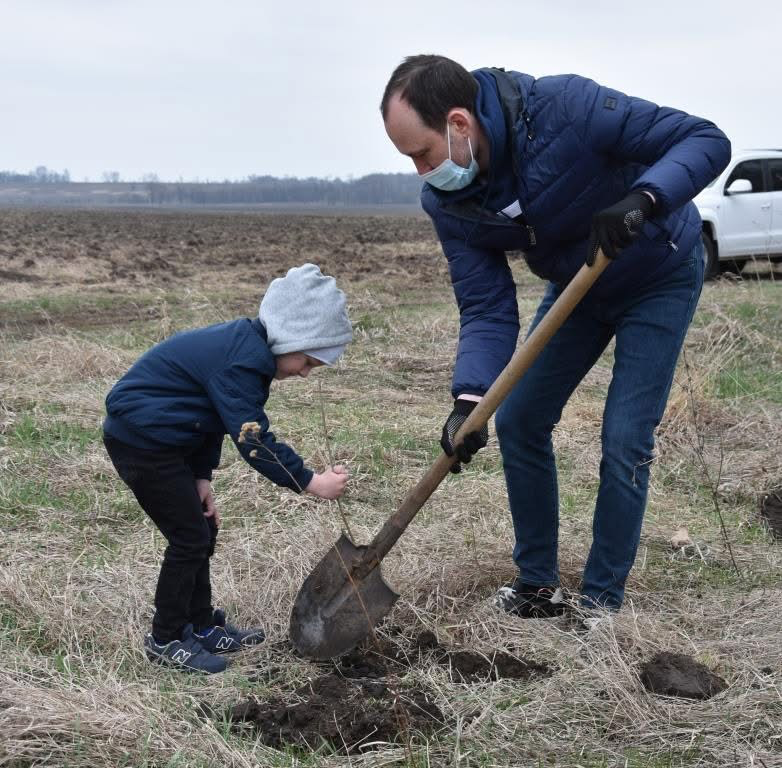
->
[103, 318, 313, 491]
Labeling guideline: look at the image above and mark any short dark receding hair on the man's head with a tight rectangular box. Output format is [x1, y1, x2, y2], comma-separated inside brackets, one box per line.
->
[380, 54, 478, 131]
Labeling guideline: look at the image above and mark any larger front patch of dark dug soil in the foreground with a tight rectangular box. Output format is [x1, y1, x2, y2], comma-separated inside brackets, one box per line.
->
[229, 674, 444, 754]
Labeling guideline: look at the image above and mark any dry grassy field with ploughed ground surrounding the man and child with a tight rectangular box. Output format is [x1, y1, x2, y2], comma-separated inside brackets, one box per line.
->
[0, 210, 782, 768]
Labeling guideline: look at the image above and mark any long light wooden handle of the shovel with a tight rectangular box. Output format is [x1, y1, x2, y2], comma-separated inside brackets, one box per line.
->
[359, 250, 610, 575]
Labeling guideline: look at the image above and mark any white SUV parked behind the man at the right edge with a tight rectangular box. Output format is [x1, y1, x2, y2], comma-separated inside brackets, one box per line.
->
[695, 149, 782, 278]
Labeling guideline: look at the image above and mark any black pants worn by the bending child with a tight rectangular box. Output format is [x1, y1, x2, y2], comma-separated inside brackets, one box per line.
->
[103, 435, 217, 643]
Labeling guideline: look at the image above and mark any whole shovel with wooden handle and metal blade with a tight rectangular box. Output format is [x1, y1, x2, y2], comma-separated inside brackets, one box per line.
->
[290, 250, 609, 660]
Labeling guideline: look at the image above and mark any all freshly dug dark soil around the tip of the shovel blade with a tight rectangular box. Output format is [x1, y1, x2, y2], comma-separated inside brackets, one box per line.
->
[229, 632, 550, 754]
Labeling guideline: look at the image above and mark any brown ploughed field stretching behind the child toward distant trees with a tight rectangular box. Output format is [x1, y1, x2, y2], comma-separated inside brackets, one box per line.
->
[0, 209, 447, 301]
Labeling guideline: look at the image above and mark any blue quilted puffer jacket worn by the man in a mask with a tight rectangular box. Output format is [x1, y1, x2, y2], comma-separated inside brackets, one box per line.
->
[421, 69, 730, 397]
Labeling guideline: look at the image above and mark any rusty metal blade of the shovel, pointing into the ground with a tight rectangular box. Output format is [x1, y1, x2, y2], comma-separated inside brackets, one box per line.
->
[290, 533, 399, 660]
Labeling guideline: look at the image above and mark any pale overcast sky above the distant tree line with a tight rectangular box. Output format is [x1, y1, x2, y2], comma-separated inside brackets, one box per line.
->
[0, 0, 782, 181]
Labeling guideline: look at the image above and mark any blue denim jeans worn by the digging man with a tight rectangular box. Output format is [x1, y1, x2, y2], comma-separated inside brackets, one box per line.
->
[496, 243, 703, 609]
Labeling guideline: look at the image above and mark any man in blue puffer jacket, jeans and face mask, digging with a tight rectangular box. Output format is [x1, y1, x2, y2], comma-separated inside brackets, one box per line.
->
[381, 55, 730, 618]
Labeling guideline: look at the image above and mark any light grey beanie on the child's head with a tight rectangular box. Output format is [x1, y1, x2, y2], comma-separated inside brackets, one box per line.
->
[258, 264, 353, 355]
